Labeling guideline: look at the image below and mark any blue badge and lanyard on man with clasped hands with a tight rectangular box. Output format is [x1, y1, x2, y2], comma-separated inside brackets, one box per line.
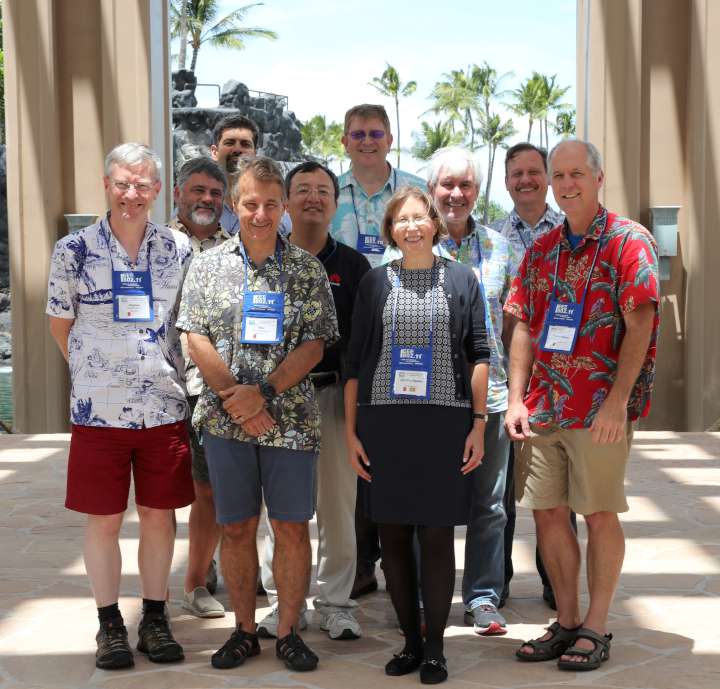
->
[240, 242, 285, 344]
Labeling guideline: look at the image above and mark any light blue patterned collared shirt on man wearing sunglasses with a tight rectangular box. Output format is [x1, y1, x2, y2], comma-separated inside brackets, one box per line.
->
[330, 164, 427, 268]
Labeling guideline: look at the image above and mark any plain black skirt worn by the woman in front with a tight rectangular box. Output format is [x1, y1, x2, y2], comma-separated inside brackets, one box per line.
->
[357, 404, 472, 526]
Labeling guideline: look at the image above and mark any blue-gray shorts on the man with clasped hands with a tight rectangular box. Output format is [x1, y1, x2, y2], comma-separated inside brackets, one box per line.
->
[203, 430, 317, 524]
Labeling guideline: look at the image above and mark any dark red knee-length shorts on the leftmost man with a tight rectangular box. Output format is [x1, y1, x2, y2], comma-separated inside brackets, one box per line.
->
[65, 421, 195, 514]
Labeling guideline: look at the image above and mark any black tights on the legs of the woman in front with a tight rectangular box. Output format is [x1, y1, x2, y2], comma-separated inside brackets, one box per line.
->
[378, 524, 455, 659]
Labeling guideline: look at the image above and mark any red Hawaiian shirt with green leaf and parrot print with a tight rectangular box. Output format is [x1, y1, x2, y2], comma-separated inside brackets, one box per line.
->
[505, 207, 659, 428]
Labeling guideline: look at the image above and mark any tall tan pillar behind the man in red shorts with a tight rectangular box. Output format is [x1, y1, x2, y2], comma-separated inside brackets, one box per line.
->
[3, 0, 172, 433]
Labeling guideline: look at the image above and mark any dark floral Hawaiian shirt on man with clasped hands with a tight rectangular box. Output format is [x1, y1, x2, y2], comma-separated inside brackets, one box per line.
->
[177, 235, 339, 452]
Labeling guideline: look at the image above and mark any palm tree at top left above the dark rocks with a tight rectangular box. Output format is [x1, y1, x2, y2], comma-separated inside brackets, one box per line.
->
[170, 0, 277, 71]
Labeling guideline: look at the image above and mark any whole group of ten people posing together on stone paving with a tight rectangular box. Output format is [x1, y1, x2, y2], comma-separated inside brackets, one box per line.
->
[47, 105, 658, 684]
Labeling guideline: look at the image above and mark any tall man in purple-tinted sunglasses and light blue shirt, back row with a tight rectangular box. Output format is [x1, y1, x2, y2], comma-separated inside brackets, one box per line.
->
[330, 104, 426, 598]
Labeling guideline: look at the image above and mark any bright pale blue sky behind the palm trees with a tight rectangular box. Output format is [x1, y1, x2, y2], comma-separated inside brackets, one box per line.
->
[183, 0, 576, 209]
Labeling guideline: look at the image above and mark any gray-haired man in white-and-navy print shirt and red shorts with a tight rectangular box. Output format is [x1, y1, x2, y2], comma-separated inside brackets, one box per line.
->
[46, 143, 194, 670]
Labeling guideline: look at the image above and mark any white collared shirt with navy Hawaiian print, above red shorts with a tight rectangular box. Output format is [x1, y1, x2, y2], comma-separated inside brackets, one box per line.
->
[46, 219, 191, 429]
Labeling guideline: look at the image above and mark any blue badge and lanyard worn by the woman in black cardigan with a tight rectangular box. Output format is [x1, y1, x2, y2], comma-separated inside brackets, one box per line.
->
[390, 261, 436, 400]
